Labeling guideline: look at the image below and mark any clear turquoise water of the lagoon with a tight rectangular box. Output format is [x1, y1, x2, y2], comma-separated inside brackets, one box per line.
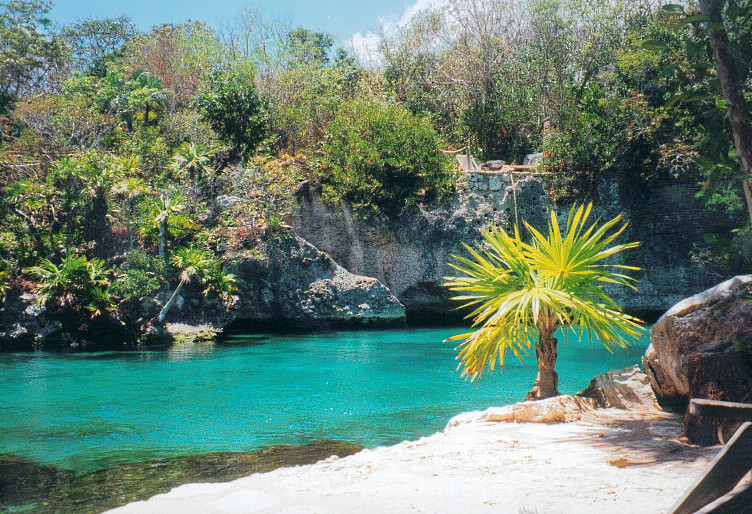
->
[0, 329, 648, 473]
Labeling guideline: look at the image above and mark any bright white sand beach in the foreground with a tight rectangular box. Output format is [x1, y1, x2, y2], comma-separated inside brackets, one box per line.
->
[112, 409, 718, 514]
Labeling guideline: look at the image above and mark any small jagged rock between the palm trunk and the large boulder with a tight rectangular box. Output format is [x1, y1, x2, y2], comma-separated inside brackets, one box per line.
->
[577, 365, 658, 410]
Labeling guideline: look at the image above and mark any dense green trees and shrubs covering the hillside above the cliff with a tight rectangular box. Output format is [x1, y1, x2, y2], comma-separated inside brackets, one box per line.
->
[0, 0, 752, 336]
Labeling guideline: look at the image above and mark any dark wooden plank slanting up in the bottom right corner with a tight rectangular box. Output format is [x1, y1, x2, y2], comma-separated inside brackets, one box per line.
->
[671, 422, 752, 514]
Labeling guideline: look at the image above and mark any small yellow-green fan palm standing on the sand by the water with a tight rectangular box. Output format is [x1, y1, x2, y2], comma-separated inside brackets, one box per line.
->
[445, 204, 641, 400]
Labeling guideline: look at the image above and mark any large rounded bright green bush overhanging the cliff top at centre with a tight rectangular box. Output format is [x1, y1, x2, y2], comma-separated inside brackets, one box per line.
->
[317, 98, 455, 216]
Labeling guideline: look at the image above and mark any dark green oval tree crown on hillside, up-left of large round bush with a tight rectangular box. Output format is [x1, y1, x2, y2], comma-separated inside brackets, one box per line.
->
[196, 69, 269, 158]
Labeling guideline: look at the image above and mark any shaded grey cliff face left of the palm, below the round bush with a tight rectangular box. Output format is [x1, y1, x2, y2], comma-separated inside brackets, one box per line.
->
[294, 177, 551, 320]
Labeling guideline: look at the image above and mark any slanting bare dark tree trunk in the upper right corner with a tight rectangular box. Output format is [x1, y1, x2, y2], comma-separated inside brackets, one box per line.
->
[700, 0, 752, 225]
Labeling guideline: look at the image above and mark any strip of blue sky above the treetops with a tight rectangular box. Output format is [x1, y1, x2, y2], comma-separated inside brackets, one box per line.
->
[51, 0, 418, 44]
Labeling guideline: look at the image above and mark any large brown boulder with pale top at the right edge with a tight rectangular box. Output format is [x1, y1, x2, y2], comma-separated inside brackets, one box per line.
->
[643, 275, 752, 410]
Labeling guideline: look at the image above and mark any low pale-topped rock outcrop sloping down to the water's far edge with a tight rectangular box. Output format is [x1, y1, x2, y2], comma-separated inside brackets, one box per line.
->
[173, 235, 405, 331]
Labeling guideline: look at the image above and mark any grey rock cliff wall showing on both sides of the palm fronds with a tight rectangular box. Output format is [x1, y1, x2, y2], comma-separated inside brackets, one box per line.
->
[294, 174, 735, 321]
